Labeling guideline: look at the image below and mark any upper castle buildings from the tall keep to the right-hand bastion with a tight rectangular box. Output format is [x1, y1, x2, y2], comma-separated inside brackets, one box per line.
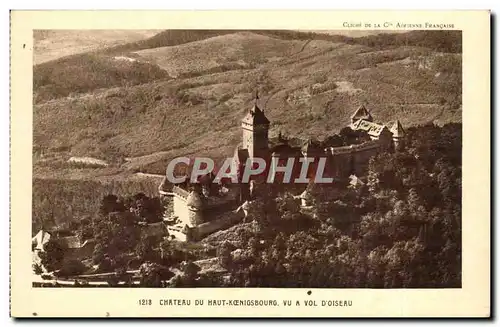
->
[233, 98, 404, 186]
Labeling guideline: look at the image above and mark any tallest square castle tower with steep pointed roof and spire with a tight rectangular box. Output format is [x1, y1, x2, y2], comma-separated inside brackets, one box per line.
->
[241, 94, 269, 158]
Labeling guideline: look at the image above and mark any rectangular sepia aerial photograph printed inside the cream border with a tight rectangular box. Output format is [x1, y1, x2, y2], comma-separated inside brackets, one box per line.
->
[29, 29, 463, 290]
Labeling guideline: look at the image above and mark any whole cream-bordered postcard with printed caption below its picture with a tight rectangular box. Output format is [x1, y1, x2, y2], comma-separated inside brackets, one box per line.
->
[10, 10, 491, 318]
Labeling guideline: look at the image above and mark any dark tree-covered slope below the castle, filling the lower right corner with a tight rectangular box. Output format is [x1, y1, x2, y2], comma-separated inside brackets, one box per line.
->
[198, 124, 462, 288]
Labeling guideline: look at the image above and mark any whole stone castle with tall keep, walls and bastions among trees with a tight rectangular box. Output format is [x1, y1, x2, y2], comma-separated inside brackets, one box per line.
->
[159, 96, 405, 241]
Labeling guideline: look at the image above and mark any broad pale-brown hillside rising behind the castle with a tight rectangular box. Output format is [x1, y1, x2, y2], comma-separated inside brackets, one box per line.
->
[34, 31, 461, 176]
